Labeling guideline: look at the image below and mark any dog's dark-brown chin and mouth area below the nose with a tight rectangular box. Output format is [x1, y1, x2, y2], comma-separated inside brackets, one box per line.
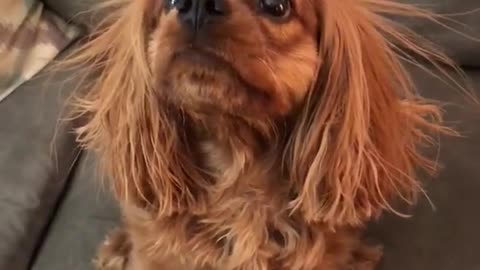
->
[162, 50, 278, 118]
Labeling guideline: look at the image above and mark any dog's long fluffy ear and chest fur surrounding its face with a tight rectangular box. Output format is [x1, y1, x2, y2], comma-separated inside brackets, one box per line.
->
[65, 0, 454, 270]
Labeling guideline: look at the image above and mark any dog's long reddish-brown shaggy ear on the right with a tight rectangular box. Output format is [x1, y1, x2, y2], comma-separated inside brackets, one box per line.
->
[286, 0, 451, 225]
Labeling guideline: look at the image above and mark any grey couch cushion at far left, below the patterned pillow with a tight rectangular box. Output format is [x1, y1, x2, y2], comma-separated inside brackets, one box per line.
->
[0, 49, 78, 270]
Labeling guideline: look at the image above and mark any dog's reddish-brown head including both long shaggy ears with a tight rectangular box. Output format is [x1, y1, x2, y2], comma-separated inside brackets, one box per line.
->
[73, 0, 449, 225]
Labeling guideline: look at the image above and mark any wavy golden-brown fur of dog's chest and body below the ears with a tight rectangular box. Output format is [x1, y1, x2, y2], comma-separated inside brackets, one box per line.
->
[124, 137, 368, 270]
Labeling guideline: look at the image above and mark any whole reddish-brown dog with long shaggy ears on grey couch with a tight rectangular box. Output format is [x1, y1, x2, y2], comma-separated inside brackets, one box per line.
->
[65, 0, 452, 270]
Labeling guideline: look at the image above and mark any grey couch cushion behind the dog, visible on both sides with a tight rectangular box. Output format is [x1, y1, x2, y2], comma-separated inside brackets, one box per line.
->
[33, 66, 480, 270]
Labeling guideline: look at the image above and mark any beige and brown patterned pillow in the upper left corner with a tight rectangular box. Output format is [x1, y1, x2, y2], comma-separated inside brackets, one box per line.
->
[0, 0, 80, 101]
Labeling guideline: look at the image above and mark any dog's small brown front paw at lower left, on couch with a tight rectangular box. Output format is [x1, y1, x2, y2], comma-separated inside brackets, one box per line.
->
[93, 230, 131, 270]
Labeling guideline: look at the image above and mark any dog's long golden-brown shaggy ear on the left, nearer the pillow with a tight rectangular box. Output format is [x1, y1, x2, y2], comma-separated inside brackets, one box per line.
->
[62, 0, 205, 215]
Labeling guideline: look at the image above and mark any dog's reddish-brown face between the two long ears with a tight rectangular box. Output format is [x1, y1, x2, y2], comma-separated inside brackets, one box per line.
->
[152, 0, 319, 119]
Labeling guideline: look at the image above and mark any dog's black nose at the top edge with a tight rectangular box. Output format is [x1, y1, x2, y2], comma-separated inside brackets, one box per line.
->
[169, 0, 227, 32]
